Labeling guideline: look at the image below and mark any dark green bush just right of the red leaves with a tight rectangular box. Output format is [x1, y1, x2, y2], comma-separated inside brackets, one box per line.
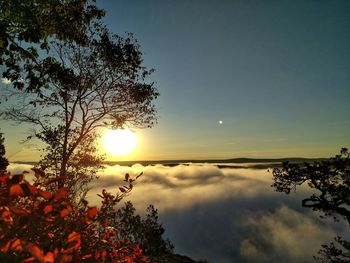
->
[112, 202, 174, 257]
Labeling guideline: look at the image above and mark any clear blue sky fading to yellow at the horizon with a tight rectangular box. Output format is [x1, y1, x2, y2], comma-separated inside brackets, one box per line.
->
[1, 0, 350, 160]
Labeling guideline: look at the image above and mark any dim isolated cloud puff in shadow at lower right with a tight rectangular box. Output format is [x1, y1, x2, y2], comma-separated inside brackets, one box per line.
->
[240, 205, 334, 262]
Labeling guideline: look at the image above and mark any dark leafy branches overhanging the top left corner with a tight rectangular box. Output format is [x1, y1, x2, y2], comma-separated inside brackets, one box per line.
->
[0, 0, 104, 91]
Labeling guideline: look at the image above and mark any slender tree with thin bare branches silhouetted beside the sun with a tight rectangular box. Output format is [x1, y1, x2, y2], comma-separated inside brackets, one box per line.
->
[2, 18, 158, 198]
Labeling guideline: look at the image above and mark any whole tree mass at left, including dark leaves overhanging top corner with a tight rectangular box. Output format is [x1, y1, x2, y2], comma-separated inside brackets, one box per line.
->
[0, 1, 159, 198]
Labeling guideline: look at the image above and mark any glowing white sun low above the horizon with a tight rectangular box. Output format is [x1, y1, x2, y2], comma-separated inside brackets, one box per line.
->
[103, 129, 137, 156]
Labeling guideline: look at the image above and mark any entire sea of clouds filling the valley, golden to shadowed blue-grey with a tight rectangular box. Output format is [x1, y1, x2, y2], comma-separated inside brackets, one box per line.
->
[9, 164, 349, 263]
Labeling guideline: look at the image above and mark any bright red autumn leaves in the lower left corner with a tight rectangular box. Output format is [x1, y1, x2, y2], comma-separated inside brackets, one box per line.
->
[0, 171, 149, 263]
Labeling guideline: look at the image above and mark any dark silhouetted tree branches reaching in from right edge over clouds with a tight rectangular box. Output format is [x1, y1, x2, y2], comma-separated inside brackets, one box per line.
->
[272, 148, 350, 262]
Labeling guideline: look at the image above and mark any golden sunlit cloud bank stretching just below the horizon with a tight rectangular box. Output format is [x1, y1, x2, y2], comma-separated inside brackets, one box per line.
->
[89, 165, 273, 210]
